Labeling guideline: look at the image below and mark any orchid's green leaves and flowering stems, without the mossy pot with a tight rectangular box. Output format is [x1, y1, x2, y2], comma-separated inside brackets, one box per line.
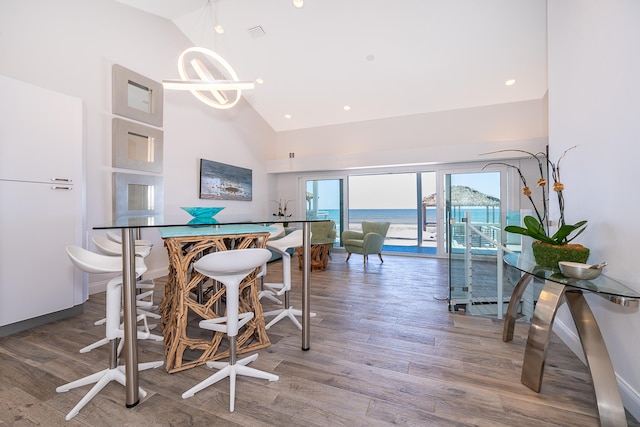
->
[485, 145, 587, 246]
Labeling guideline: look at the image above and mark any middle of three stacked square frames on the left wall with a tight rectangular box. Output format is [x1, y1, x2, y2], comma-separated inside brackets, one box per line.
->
[111, 117, 164, 173]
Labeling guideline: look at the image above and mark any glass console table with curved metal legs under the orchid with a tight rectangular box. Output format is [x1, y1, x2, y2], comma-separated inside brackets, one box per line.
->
[502, 254, 640, 426]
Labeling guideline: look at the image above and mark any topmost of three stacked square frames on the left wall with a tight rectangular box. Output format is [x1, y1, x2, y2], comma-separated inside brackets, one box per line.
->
[111, 64, 164, 127]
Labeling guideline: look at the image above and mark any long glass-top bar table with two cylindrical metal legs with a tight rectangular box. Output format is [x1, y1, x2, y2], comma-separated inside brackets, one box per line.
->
[93, 216, 327, 408]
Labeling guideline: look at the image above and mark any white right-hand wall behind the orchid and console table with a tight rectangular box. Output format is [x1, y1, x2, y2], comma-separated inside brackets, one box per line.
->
[548, 0, 640, 419]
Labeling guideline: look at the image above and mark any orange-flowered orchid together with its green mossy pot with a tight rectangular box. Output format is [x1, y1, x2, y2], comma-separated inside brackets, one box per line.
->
[487, 145, 589, 268]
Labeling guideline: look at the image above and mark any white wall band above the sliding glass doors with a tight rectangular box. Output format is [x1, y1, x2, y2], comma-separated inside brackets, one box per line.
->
[269, 94, 547, 173]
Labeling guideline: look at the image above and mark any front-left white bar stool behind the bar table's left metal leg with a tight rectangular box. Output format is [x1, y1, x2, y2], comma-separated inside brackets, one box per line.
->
[56, 245, 164, 421]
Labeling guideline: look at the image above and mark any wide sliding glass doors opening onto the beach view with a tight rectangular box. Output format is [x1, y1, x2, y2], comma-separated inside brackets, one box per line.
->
[299, 165, 501, 256]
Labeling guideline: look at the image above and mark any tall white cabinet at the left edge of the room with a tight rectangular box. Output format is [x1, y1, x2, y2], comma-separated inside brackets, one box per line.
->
[0, 76, 87, 336]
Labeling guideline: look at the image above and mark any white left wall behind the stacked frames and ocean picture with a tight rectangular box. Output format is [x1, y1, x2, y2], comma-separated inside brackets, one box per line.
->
[0, 0, 275, 288]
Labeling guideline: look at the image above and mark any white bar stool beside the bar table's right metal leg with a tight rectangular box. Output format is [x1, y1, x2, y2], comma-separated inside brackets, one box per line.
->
[264, 230, 316, 330]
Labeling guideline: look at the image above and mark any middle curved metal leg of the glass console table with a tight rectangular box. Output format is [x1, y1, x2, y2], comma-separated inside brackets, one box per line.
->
[521, 281, 566, 392]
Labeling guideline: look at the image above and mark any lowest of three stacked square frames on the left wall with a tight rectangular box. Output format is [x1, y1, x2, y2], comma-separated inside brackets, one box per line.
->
[113, 172, 164, 218]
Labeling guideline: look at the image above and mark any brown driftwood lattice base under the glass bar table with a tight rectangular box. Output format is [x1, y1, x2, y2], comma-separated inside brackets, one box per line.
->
[160, 233, 271, 373]
